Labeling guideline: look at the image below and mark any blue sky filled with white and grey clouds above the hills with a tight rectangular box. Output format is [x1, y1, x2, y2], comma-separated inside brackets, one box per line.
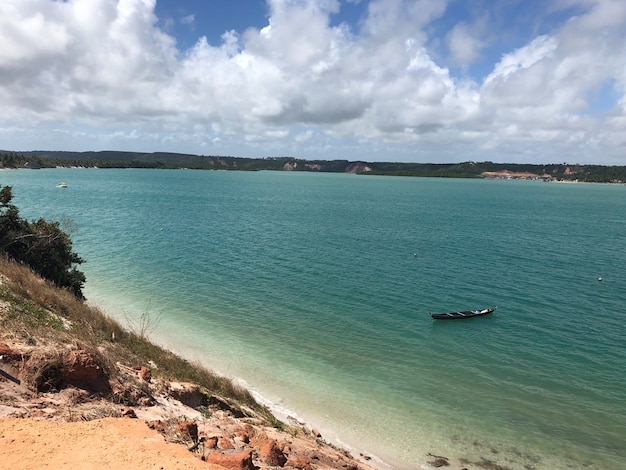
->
[0, 0, 626, 165]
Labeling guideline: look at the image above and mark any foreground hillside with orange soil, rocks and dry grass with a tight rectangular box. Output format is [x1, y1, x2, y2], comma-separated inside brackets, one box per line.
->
[0, 258, 380, 470]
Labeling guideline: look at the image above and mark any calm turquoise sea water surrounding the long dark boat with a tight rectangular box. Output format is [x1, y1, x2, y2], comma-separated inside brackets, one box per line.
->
[0, 169, 626, 470]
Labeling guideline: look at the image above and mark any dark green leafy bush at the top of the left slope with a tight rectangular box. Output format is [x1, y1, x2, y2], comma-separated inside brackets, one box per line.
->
[0, 186, 85, 299]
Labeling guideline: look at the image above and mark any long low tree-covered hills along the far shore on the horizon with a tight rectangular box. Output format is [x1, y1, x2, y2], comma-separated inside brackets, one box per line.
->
[0, 151, 626, 183]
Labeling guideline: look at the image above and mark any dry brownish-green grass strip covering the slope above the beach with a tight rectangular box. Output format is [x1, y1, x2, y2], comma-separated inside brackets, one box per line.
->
[0, 256, 283, 428]
